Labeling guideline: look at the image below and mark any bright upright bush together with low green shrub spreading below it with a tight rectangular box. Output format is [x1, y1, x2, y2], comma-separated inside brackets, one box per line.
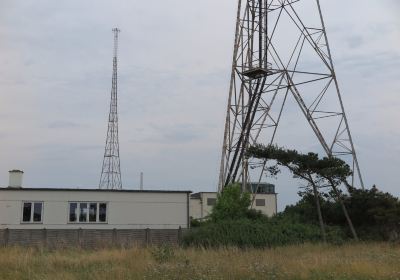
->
[183, 184, 343, 248]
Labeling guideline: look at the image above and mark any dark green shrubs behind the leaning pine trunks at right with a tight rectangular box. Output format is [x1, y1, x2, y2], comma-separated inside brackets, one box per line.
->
[281, 186, 400, 240]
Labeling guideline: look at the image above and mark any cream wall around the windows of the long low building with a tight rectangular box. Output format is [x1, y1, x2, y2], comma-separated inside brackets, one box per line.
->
[0, 190, 189, 229]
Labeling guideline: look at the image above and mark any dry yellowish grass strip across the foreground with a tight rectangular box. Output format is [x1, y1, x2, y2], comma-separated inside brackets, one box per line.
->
[0, 243, 400, 280]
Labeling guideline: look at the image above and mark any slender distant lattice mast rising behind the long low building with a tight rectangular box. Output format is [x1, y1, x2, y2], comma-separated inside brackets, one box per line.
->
[99, 28, 122, 189]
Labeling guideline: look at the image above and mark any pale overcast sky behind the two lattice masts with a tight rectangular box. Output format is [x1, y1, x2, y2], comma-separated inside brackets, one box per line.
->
[0, 0, 400, 209]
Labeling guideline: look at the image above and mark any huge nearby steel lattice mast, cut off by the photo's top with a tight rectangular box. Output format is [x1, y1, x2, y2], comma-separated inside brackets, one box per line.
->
[218, 0, 364, 191]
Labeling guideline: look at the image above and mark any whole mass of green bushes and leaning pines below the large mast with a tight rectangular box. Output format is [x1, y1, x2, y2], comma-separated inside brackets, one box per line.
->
[184, 145, 400, 248]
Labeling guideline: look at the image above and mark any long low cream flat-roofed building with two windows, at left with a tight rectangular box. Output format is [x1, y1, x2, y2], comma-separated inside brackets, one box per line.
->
[0, 187, 190, 229]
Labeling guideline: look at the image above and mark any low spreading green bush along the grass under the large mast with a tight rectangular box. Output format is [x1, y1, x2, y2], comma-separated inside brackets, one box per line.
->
[183, 219, 343, 248]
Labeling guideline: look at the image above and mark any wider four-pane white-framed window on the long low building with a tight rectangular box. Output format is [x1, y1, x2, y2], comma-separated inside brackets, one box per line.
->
[68, 202, 107, 223]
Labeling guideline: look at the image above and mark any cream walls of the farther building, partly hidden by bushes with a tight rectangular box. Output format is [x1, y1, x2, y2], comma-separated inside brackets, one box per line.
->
[190, 192, 277, 219]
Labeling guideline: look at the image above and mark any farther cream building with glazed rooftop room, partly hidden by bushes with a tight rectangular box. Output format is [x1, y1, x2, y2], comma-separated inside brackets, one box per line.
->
[190, 183, 277, 220]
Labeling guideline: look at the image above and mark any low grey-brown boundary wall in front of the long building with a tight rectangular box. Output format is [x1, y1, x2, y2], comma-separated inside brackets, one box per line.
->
[0, 228, 187, 248]
